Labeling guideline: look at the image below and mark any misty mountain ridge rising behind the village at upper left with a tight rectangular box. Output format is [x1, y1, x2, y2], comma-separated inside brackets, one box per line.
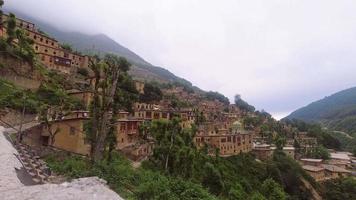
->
[5, 10, 191, 85]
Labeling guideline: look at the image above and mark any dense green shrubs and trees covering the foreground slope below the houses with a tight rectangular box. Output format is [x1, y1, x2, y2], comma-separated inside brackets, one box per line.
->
[46, 136, 315, 200]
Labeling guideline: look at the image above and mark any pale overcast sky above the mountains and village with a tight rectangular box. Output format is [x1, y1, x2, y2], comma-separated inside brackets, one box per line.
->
[5, 0, 356, 118]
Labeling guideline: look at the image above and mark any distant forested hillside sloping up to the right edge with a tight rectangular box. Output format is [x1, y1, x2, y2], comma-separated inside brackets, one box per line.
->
[286, 87, 356, 133]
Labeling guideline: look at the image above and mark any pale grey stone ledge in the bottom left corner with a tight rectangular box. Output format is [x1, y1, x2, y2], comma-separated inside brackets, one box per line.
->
[0, 126, 122, 200]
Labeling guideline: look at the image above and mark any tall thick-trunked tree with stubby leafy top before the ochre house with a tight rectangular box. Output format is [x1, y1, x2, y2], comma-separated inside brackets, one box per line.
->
[86, 54, 130, 162]
